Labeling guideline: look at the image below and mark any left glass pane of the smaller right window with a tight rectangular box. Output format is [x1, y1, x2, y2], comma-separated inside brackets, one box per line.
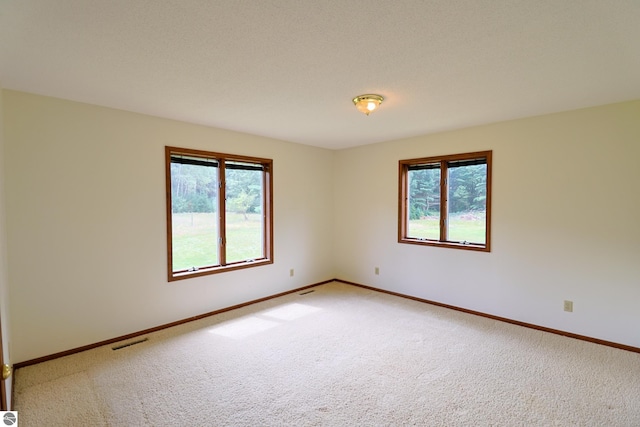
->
[407, 164, 440, 240]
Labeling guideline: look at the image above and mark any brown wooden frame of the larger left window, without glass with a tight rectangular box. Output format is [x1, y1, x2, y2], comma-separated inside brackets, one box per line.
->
[165, 146, 273, 282]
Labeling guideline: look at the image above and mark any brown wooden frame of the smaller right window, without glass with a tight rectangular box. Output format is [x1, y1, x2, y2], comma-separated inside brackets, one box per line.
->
[398, 151, 493, 252]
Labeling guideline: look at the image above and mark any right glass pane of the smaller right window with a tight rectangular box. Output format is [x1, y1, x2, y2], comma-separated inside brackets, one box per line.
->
[447, 164, 487, 244]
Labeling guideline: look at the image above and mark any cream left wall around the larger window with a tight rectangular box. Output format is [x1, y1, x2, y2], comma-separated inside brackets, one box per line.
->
[4, 91, 334, 362]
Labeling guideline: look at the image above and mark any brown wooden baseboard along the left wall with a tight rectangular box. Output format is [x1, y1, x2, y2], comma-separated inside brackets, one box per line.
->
[13, 279, 334, 370]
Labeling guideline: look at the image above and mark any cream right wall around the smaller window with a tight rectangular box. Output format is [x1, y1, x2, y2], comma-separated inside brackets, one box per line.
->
[334, 101, 640, 347]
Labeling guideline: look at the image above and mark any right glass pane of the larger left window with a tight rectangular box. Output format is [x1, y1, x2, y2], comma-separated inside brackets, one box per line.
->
[225, 162, 265, 263]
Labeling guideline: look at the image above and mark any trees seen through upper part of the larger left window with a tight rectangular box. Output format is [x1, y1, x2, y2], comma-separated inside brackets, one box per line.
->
[171, 163, 262, 219]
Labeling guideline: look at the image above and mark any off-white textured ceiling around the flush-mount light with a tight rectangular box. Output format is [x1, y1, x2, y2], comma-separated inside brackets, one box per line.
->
[0, 0, 640, 149]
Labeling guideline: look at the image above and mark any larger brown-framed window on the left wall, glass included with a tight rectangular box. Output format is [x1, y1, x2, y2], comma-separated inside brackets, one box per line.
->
[165, 147, 273, 281]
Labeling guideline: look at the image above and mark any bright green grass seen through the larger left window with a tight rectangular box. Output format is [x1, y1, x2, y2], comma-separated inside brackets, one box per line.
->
[172, 213, 263, 271]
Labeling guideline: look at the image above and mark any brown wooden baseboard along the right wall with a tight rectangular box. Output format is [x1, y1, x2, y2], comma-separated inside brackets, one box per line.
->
[335, 279, 640, 353]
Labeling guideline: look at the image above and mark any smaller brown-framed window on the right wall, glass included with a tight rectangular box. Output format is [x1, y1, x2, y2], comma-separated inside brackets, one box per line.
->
[398, 151, 491, 252]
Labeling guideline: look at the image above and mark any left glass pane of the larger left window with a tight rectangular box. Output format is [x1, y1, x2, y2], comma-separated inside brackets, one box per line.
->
[171, 159, 219, 271]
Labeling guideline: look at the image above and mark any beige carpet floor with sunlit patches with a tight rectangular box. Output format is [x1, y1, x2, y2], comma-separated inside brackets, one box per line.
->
[15, 283, 640, 427]
